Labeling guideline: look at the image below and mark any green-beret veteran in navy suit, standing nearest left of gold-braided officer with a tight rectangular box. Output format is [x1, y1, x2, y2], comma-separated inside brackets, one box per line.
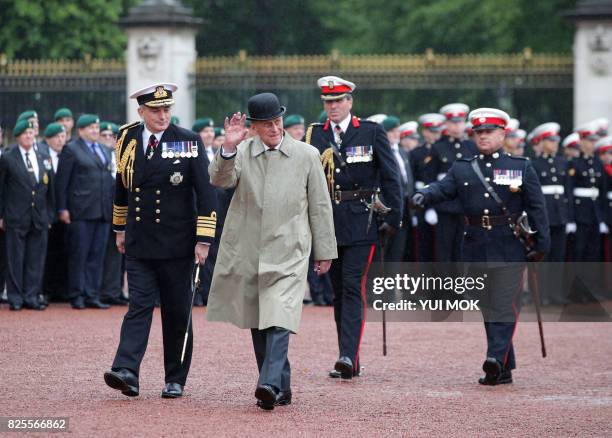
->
[56, 114, 113, 309]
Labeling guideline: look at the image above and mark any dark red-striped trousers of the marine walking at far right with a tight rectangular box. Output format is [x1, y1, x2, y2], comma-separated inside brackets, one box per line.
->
[479, 263, 525, 370]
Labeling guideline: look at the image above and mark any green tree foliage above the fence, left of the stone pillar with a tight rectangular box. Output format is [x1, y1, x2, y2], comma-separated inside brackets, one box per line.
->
[0, 0, 138, 59]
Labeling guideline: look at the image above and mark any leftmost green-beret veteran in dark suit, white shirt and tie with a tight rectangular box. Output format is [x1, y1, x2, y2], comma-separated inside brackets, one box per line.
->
[0, 119, 54, 310]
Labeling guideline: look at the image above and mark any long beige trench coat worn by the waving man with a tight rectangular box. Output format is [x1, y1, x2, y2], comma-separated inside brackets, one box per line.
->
[206, 133, 338, 333]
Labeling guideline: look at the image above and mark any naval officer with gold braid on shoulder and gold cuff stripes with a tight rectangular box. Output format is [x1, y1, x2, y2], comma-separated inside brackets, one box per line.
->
[104, 84, 217, 398]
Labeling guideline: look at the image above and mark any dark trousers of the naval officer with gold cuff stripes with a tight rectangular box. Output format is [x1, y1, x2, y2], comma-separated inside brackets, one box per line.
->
[113, 256, 193, 385]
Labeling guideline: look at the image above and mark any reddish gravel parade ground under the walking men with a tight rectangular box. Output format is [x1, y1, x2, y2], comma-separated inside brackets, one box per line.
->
[0, 304, 612, 438]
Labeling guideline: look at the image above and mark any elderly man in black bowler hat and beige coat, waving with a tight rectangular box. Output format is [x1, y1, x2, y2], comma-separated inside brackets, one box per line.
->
[206, 93, 337, 410]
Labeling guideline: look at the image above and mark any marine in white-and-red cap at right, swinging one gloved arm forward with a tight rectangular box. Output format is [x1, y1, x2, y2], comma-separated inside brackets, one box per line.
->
[413, 108, 550, 385]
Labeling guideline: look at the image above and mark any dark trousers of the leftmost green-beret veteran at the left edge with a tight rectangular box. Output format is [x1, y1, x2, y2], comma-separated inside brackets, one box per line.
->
[6, 228, 47, 305]
